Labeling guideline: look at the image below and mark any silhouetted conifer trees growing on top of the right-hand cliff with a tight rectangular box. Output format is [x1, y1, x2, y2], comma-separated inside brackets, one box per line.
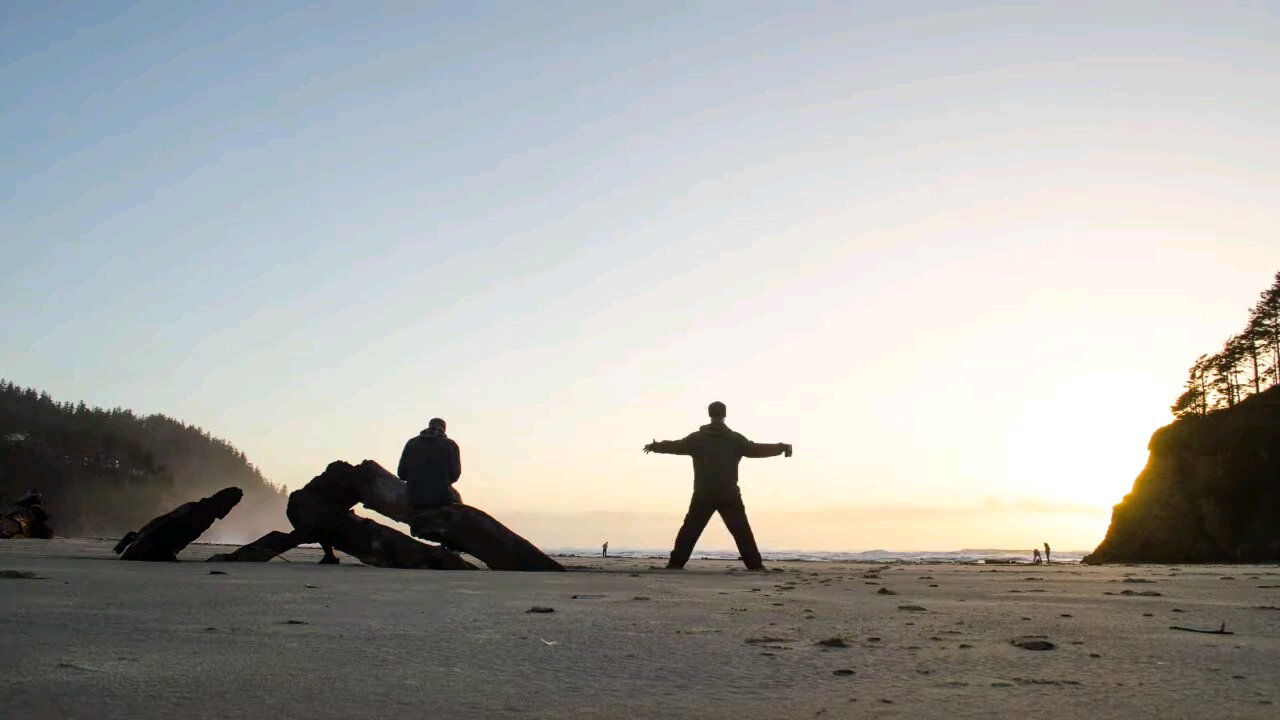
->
[1170, 267, 1280, 418]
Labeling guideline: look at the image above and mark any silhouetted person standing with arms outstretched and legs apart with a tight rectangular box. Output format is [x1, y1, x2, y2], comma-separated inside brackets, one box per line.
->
[644, 402, 791, 570]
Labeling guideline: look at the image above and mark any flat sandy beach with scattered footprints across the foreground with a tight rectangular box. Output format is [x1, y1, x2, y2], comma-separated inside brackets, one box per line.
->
[0, 539, 1280, 719]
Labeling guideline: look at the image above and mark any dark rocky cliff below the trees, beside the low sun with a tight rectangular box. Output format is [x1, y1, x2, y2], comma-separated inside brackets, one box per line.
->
[1084, 387, 1280, 564]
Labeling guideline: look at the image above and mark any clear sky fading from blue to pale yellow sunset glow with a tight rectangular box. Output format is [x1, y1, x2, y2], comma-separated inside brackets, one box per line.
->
[0, 0, 1280, 550]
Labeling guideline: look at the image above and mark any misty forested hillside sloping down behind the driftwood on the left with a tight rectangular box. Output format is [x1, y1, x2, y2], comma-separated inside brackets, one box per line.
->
[0, 379, 284, 536]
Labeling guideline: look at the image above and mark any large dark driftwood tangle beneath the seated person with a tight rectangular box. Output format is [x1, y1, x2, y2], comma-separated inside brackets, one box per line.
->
[210, 460, 563, 571]
